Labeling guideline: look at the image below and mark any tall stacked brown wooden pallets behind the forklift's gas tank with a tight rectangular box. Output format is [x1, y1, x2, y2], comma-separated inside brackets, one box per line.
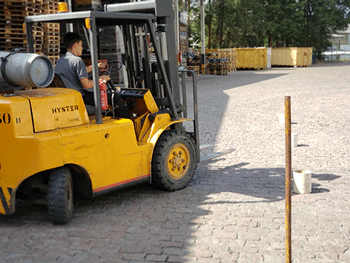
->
[0, 0, 60, 61]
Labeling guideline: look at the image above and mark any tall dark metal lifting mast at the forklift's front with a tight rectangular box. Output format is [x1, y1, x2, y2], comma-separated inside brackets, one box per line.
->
[104, 0, 182, 119]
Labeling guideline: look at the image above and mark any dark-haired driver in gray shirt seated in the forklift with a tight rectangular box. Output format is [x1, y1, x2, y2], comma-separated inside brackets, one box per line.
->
[55, 32, 128, 118]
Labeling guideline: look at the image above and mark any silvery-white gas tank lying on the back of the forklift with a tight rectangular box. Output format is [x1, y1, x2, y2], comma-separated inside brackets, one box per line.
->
[0, 52, 55, 88]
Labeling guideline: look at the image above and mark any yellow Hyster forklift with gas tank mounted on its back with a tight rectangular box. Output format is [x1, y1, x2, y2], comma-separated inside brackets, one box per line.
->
[0, 0, 200, 224]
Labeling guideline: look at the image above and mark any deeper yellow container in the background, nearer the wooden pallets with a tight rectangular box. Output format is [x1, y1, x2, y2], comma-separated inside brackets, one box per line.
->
[236, 48, 267, 69]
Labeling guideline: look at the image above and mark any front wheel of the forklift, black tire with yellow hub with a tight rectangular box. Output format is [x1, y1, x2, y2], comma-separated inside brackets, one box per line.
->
[152, 130, 197, 191]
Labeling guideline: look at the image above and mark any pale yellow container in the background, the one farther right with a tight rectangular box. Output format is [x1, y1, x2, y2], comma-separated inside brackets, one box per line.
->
[271, 47, 313, 67]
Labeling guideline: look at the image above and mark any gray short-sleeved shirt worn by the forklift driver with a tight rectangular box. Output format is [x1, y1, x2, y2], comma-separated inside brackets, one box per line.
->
[55, 52, 89, 94]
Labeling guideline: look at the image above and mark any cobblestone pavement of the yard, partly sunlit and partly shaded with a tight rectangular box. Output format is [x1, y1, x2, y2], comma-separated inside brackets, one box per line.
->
[0, 63, 350, 263]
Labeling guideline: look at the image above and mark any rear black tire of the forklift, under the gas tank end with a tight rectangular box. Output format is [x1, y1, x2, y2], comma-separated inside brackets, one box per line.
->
[48, 167, 74, 224]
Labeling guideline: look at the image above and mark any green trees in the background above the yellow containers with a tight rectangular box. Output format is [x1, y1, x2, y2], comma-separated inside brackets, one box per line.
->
[190, 0, 350, 54]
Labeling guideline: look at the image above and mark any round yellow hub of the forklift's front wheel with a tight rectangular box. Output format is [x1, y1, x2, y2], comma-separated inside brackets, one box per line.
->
[166, 143, 191, 179]
